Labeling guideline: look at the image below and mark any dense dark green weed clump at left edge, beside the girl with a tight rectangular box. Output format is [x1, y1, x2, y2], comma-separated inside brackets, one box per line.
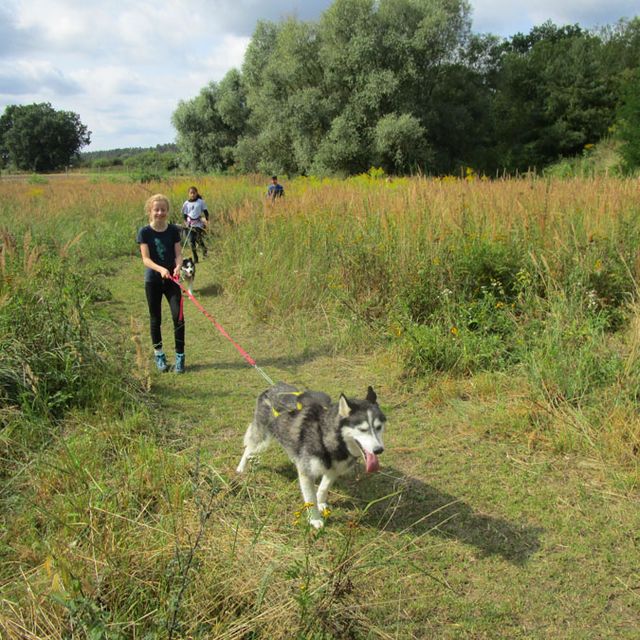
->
[0, 256, 139, 428]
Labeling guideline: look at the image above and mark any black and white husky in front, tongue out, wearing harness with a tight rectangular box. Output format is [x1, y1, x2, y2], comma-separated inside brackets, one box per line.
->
[237, 382, 386, 529]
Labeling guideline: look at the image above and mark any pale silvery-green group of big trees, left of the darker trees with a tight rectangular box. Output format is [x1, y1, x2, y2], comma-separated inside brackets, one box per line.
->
[174, 0, 469, 175]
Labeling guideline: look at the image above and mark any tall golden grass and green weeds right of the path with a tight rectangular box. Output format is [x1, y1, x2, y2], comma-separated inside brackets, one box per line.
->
[212, 176, 640, 462]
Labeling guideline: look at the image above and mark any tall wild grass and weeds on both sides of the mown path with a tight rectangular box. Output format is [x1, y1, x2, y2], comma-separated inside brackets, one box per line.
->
[0, 176, 640, 639]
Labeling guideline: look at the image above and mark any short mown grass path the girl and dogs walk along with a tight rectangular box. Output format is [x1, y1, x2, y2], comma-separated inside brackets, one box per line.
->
[112, 254, 640, 639]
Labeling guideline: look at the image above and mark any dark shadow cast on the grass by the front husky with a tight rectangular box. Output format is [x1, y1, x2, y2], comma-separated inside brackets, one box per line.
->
[348, 467, 544, 565]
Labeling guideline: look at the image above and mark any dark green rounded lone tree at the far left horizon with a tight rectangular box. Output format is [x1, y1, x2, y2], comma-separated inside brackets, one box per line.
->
[0, 102, 91, 171]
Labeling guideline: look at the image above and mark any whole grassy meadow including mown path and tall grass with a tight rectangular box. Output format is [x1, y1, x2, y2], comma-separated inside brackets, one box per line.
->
[0, 171, 640, 639]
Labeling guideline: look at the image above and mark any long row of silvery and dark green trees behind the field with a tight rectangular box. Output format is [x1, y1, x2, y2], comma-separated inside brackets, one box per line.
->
[172, 0, 640, 175]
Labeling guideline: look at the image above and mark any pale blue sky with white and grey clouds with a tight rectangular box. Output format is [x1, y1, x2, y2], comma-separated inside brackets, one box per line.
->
[0, 0, 640, 151]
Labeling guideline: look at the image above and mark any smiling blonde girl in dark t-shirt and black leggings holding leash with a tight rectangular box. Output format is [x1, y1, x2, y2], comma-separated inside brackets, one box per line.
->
[136, 193, 185, 373]
